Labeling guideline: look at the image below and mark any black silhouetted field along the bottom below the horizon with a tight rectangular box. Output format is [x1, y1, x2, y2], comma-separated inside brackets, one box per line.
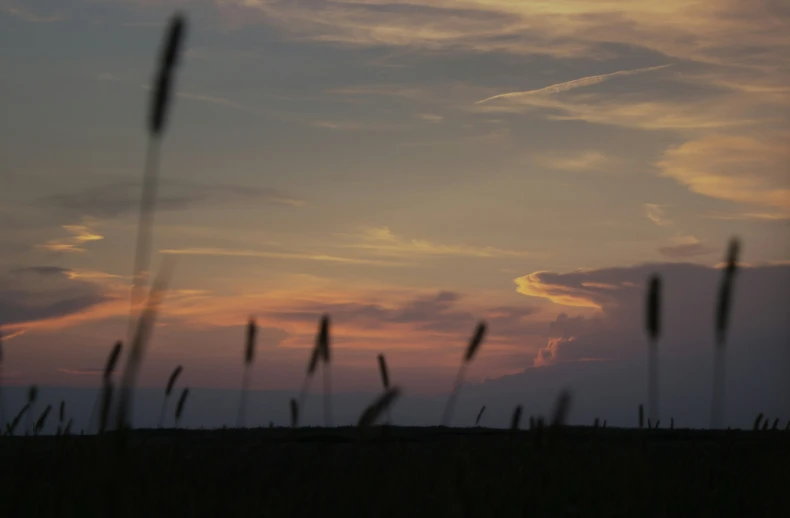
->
[0, 427, 790, 517]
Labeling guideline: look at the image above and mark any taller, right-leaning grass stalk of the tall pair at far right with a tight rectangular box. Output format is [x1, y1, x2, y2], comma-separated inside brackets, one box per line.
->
[711, 239, 740, 428]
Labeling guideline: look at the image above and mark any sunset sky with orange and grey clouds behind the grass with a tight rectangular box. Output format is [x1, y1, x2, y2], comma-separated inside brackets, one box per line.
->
[0, 0, 790, 425]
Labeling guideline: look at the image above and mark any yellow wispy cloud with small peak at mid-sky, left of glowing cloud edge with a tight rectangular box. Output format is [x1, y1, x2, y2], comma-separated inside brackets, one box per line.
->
[336, 227, 541, 258]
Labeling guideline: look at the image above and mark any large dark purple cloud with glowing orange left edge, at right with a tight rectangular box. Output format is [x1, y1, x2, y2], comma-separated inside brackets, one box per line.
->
[516, 263, 790, 364]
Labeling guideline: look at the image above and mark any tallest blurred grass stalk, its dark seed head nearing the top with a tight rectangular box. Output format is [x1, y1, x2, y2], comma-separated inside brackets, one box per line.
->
[128, 14, 186, 340]
